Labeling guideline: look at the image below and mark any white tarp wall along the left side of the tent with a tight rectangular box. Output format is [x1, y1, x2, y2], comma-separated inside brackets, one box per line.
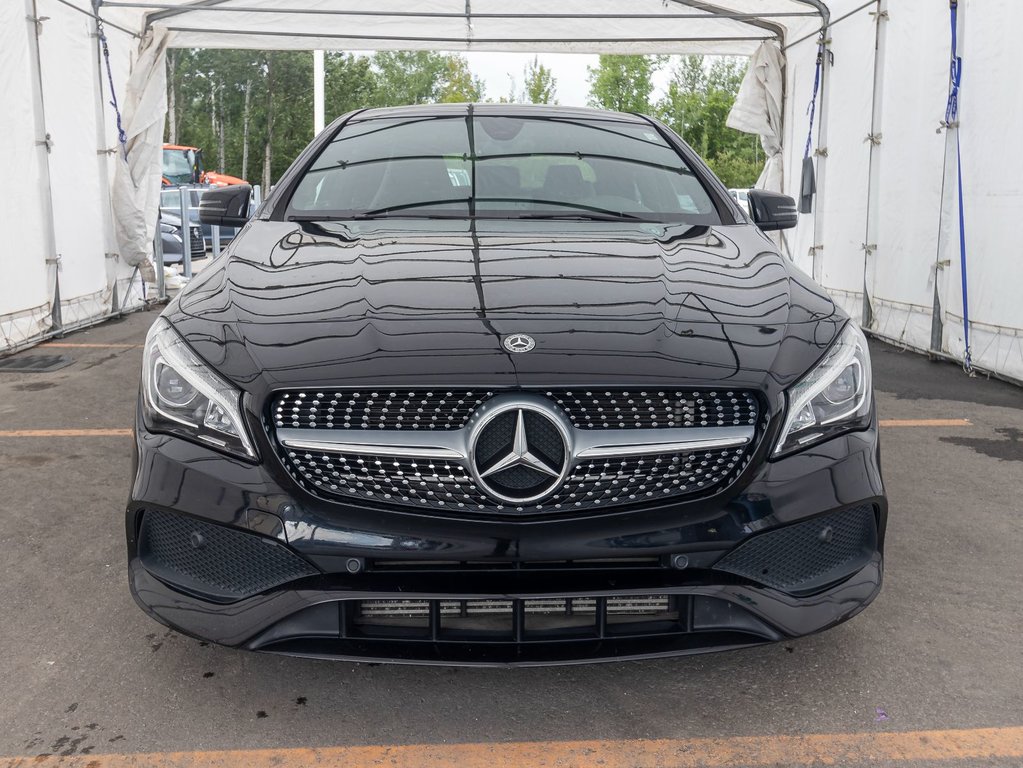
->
[0, 0, 142, 353]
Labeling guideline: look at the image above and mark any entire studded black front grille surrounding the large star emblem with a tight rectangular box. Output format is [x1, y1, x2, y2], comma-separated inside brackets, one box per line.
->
[267, 388, 764, 515]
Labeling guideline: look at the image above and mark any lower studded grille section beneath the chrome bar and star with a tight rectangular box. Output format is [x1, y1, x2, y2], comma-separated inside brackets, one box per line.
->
[285, 447, 750, 514]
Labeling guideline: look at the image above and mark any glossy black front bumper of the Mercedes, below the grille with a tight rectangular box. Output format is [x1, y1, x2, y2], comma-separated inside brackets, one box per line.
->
[126, 425, 887, 665]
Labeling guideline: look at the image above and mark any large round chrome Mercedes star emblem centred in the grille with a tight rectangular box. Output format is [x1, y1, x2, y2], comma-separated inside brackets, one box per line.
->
[471, 400, 570, 504]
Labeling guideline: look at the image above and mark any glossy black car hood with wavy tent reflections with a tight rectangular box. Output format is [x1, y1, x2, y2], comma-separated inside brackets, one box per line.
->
[166, 221, 846, 402]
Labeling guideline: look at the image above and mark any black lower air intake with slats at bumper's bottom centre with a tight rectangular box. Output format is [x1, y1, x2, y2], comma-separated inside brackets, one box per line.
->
[247, 593, 781, 665]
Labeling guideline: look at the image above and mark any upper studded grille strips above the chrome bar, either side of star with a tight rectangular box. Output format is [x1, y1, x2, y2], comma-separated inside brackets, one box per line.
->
[270, 389, 759, 430]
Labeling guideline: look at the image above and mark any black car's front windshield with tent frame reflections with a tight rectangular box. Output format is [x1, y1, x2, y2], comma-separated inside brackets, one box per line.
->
[288, 116, 720, 224]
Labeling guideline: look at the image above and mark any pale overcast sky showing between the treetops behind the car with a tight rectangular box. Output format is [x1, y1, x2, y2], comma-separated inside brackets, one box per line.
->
[463, 52, 671, 106]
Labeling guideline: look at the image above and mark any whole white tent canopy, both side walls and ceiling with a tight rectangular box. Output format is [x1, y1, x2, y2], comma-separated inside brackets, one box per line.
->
[0, 0, 1023, 379]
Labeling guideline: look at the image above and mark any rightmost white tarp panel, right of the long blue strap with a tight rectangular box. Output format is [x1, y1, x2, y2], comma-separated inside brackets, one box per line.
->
[926, 0, 1023, 379]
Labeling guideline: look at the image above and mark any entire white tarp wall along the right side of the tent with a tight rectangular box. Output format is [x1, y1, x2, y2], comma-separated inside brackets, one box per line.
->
[786, 0, 1023, 380]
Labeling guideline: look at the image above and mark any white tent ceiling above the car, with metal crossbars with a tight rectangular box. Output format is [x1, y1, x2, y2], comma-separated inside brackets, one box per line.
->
[99, 0, 828, 54]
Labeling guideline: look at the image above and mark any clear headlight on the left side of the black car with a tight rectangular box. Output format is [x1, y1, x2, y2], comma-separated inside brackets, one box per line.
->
[142, 319, 258, 459]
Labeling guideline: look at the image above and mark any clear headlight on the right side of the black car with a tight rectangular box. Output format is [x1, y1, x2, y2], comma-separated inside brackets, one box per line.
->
[773, 321, 872, 456]
